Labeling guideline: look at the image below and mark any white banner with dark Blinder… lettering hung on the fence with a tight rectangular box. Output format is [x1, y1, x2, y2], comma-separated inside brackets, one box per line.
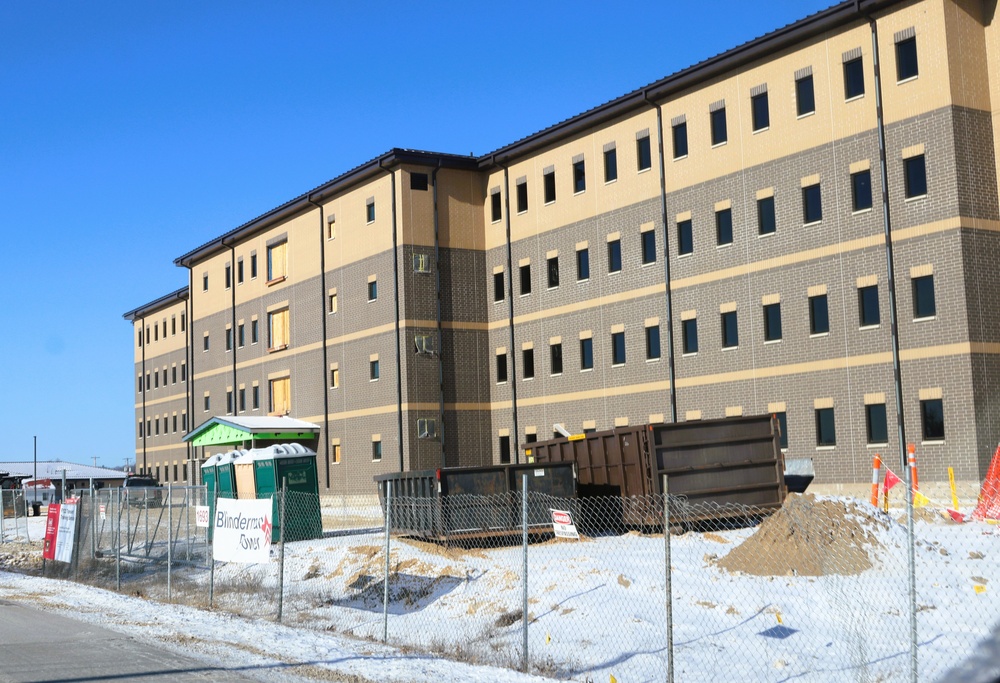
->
[212, 498, 272, 564]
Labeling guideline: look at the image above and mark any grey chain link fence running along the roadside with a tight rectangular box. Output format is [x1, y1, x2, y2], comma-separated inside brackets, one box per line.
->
[0, 486, 1000, 681]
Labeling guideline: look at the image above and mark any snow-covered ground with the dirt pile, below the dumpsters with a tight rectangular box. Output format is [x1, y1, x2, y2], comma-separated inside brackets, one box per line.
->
[0, 497, 1000, 683]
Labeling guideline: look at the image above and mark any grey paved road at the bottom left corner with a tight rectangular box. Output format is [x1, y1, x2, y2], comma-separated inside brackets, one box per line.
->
[0, 600, 262, 683]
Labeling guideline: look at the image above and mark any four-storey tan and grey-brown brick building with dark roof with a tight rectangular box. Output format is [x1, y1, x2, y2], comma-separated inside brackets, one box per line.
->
[125, 0, 1000, 492]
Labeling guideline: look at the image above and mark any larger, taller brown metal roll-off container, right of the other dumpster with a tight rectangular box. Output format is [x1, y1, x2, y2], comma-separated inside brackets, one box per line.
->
[523, 415, 786, 525]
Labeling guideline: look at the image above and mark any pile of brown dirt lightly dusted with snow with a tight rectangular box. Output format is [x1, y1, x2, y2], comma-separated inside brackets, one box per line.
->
[718, 493, 889, 576]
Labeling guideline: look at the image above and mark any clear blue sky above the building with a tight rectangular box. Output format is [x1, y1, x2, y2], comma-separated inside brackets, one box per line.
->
[0, 0, 832, 466]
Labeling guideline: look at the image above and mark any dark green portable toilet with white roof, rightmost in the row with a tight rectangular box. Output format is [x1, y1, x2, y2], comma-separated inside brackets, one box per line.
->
[238, 443, 323, 542]
